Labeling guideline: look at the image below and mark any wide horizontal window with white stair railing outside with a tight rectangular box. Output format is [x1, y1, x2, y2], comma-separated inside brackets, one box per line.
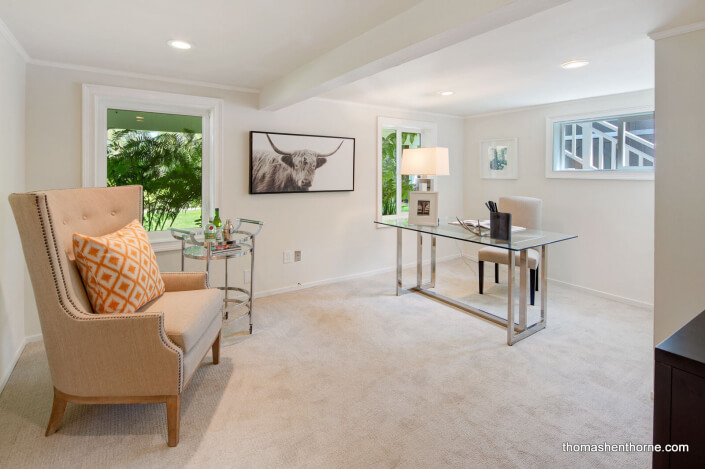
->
[546, 108, 654, 179]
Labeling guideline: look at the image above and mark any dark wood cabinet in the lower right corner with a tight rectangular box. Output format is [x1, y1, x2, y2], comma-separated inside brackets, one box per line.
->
[653, 311, 705, 469]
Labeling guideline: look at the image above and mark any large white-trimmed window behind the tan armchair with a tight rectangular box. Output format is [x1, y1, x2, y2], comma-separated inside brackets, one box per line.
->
[83, 85, 222, 251]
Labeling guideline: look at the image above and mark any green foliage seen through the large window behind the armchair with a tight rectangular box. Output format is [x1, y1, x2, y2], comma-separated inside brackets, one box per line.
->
[108, 129, 203, 231]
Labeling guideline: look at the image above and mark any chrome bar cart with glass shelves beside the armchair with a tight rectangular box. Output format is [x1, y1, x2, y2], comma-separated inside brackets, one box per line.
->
[170, 218, 264, 339]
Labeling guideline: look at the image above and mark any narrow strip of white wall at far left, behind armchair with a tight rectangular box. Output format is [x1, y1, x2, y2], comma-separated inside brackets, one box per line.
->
[0, 30, 26, 390]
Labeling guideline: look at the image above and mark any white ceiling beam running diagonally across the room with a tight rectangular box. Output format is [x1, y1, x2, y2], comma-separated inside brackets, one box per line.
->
[259, 0, 568, 111]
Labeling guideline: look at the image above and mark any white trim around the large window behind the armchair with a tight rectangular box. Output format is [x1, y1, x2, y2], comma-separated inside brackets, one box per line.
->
[82, 84, 223, 251]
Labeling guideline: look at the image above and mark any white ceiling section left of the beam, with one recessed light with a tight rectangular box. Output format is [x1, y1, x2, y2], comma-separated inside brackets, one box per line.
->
[0, 0, 420, 89]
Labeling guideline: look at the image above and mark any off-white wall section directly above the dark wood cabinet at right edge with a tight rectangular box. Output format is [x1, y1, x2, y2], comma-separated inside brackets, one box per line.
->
[654, 30, 705, 344]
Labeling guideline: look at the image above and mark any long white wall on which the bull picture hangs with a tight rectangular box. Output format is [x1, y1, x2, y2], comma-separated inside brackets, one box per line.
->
[27, 65, 463, 335]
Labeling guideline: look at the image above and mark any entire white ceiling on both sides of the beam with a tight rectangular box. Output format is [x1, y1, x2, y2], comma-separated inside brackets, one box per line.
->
[0, 0, 705, 116]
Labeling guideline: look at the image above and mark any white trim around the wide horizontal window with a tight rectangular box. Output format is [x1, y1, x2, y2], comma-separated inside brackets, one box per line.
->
[546, 106, 654, 181]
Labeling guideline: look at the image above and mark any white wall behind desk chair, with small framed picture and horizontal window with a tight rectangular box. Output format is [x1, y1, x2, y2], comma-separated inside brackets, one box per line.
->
[464, 91, 665, 304]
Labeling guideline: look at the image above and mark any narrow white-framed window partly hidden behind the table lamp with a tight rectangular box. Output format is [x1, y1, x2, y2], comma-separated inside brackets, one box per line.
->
[377, 117, 436, 219]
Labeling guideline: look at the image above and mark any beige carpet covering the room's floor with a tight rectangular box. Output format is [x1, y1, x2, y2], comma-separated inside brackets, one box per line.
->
[0, 260, 653, 468]
